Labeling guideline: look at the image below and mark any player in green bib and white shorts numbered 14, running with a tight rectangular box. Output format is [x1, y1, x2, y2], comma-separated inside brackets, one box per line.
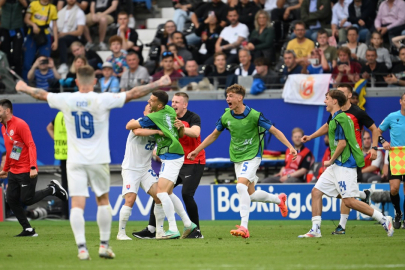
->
[298, 90, 394, 238]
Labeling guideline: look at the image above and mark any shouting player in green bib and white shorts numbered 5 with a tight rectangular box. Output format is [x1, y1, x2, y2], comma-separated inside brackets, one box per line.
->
[187, 84, 297, 238]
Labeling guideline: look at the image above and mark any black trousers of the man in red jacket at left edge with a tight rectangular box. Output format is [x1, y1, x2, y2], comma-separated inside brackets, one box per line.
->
[6, 172, 53, 229]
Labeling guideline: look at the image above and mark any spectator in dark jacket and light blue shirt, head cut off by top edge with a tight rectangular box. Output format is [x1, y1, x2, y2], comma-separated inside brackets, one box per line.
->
[301, 0, 332, 41]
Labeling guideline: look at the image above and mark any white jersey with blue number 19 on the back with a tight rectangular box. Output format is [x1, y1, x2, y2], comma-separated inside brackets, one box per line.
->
[48, 92, 126, 165]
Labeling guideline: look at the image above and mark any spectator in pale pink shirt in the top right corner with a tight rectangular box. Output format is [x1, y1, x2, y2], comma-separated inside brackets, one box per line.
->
[374, 0, 405, 46]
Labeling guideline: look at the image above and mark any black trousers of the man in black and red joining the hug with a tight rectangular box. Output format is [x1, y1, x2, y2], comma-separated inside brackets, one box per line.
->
[149, 164, 205, 228]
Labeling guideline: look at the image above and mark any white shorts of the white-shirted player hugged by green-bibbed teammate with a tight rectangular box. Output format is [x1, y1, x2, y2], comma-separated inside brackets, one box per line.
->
[121, 167, 158, 197]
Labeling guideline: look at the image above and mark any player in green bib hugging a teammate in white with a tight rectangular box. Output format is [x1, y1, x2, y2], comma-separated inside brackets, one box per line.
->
[127, 90, 197, 239]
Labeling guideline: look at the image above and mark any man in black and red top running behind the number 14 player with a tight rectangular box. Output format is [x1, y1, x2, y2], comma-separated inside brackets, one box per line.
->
[302, 84, 379, 234]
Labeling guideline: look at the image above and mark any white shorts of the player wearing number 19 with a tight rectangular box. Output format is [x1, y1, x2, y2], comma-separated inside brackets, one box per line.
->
[66, 163, 110, 197]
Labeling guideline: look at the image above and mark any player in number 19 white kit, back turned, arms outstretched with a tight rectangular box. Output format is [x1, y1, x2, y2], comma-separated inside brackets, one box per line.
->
[16, 66, 171, 260]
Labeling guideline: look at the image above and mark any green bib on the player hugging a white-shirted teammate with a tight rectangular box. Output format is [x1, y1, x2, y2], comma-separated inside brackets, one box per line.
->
[148, 105, 184, 156]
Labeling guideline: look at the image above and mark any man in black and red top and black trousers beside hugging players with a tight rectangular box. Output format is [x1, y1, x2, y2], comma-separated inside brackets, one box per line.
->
[132, 92, 205, 239]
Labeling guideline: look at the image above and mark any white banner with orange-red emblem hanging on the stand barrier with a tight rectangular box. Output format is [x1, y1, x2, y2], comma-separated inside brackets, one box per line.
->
[282, 74, 332, 105]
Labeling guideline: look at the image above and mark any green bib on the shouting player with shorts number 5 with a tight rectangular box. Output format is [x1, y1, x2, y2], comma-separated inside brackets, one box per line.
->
[221, 108, 266, 162]
